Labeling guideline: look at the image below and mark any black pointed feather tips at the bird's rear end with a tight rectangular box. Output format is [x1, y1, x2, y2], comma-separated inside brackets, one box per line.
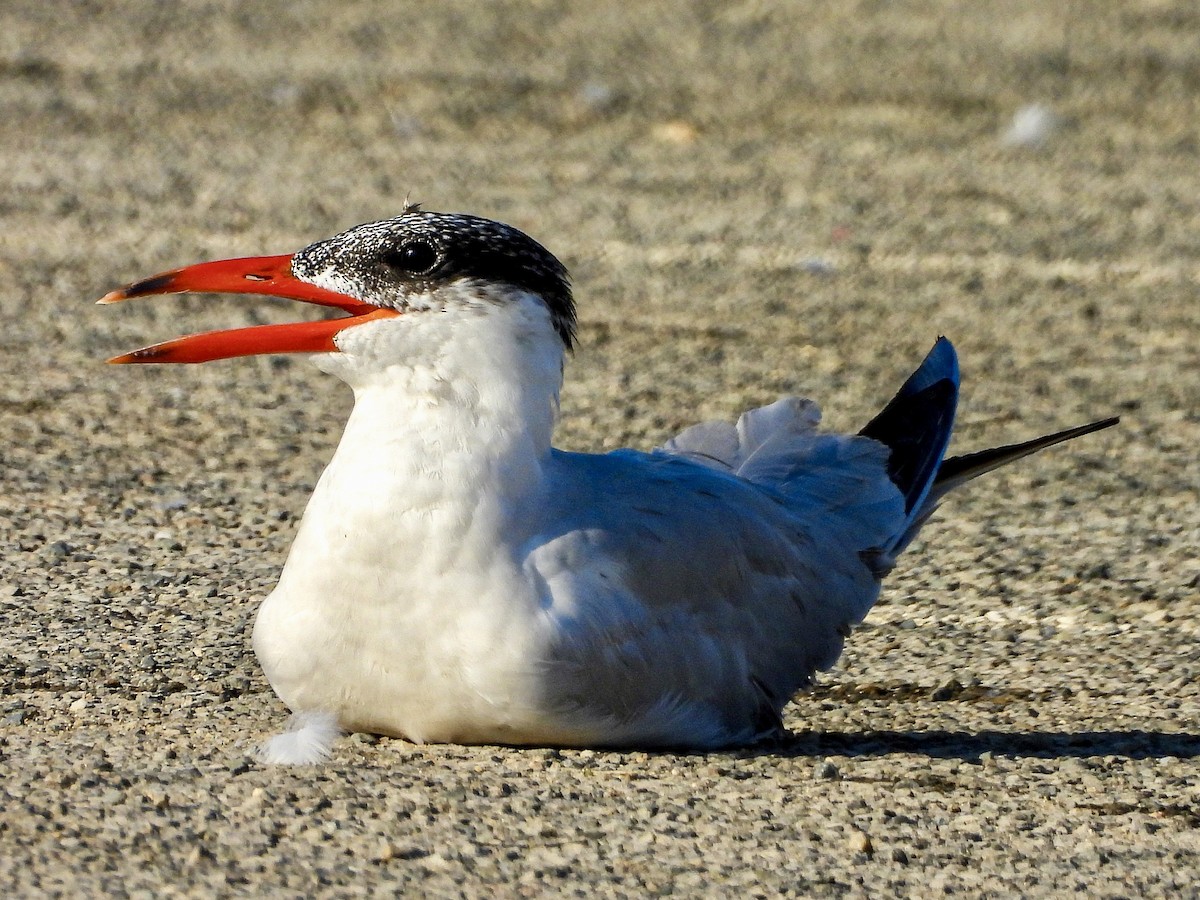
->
[859, 337, 1120, 557]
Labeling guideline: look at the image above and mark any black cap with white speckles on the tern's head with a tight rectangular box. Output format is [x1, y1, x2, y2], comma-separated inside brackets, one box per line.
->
[292, 208, 575, 349]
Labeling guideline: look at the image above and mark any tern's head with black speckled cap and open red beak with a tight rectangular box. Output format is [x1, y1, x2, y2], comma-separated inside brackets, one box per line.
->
[100, 206, 575, 362]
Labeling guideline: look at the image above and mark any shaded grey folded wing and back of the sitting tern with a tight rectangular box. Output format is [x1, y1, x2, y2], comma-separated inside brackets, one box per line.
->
[524, 400, 904, 746]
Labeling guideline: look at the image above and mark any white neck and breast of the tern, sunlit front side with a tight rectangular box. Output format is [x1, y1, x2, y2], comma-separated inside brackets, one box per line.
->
[254, 294, 609, 743]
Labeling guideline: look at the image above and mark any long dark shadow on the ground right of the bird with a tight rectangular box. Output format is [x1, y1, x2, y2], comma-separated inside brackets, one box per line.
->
[739, 728, 1200, 761]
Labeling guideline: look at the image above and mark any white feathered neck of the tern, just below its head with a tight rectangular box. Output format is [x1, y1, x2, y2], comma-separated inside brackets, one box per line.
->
[309, 301, 563, 536]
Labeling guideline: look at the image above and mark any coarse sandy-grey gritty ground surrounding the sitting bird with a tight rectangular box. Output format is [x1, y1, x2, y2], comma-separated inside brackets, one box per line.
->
[0, 0, 1200, 896]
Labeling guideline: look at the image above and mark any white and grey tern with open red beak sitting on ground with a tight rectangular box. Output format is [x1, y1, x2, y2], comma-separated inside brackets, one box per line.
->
[101, 208, 1116, 762]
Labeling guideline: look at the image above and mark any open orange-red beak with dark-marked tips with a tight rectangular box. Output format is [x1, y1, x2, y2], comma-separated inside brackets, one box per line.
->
[97, 253, 397, 364]
